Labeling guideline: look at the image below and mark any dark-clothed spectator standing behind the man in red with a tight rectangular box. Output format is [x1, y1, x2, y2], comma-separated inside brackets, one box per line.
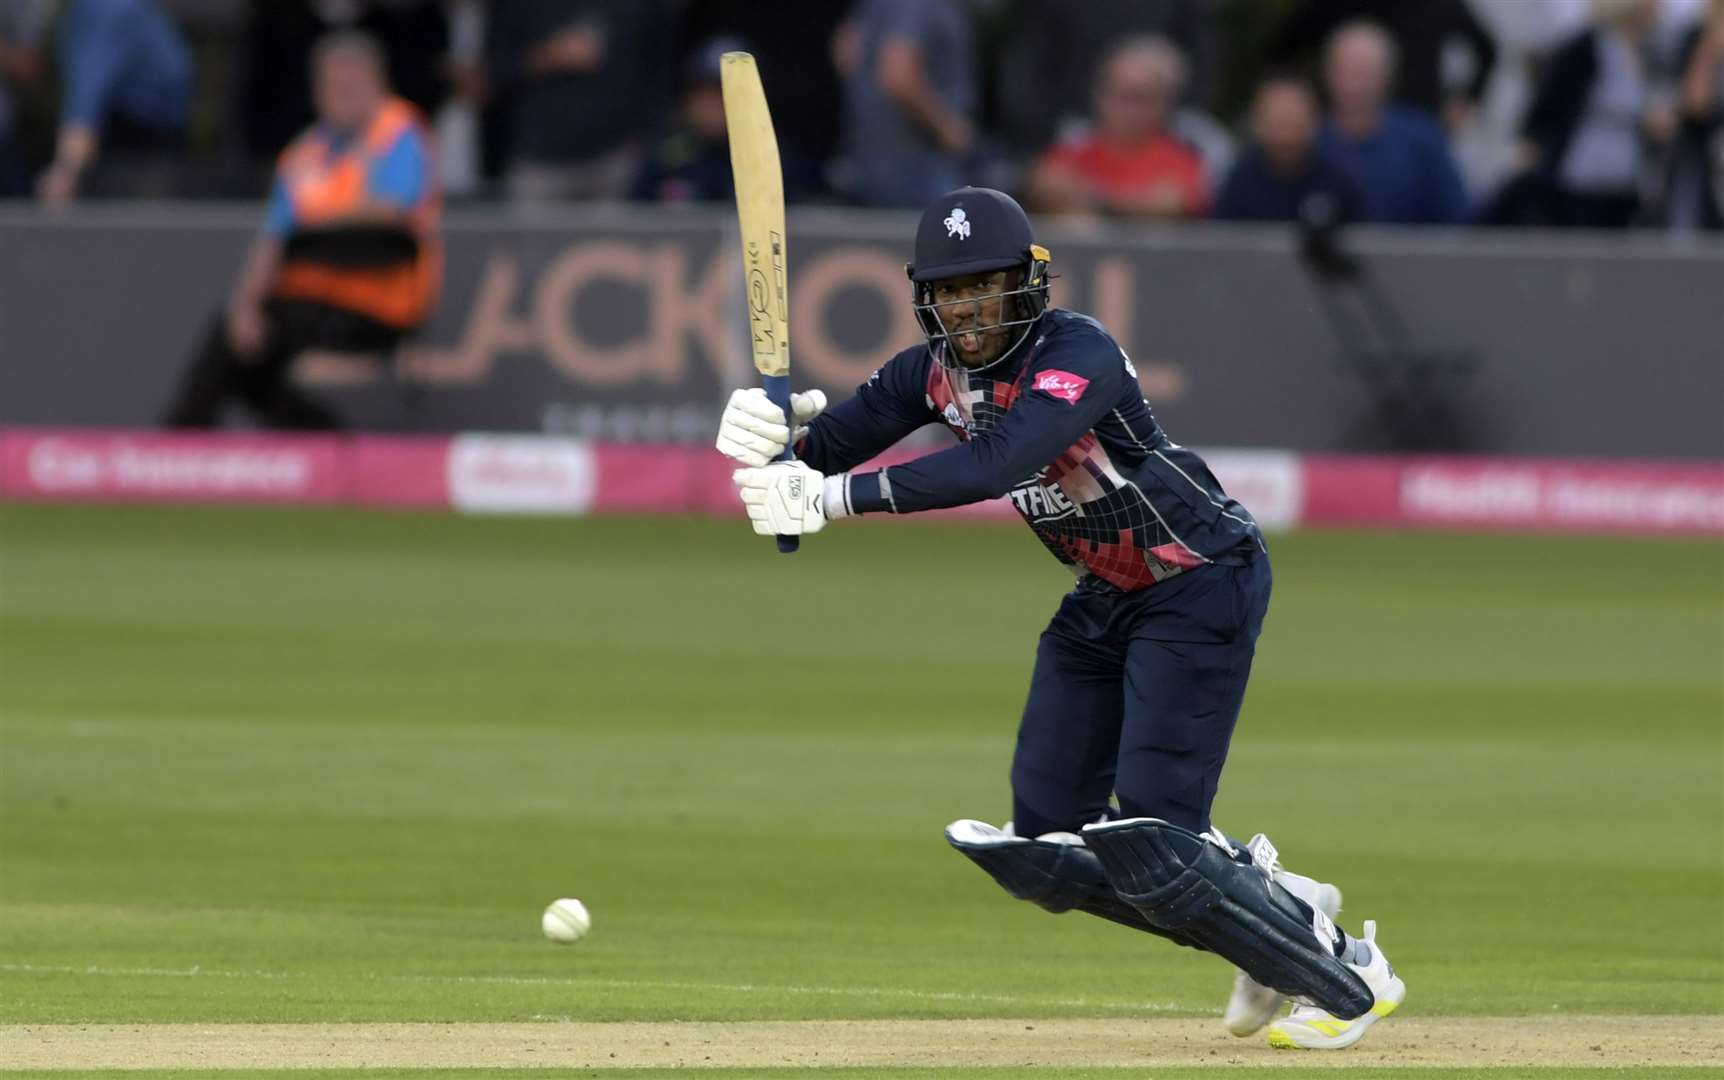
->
[996, 0, 1221, 153]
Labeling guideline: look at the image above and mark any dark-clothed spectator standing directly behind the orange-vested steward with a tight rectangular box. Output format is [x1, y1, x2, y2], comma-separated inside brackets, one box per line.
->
[238, 0, 450, 181]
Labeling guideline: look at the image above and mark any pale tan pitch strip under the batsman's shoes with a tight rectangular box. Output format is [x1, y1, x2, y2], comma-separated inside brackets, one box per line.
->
[0, 1016, 1724, 1070]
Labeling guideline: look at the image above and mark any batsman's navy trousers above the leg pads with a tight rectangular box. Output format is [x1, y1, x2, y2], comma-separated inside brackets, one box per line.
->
[1012, 550, 1271, 837]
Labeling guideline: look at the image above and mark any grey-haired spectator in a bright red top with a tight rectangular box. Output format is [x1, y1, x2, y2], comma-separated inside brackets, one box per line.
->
[1029, 38, 1209, 217]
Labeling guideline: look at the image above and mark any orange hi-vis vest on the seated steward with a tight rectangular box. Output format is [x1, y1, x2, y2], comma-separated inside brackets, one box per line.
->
[271, 98, 443, 328]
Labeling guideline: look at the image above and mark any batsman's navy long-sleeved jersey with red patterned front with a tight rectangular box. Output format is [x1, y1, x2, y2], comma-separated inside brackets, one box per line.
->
[796, 309, 1262, 590]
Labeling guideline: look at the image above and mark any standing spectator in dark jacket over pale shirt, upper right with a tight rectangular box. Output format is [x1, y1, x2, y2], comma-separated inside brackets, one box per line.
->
[1517, 0, 1676, 228]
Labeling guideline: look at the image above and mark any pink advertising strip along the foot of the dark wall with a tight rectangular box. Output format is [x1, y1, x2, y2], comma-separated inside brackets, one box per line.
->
[0, 428, 1724, 537]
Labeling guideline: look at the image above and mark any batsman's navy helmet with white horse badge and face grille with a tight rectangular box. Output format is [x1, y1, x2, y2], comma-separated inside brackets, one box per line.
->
[903, 188, 1052, 371]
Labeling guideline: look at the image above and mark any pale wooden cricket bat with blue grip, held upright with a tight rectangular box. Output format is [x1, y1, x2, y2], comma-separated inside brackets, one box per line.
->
[719, 52, 798, 554]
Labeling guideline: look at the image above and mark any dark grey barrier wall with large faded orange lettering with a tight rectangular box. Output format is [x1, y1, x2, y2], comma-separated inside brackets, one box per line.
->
[0, 207, 1724, 459]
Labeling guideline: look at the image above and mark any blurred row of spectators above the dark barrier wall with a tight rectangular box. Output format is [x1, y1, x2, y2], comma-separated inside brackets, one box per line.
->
[0, 0, 1724, 229]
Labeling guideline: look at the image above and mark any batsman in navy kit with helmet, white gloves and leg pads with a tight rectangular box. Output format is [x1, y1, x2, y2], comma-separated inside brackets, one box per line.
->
[717, 188, 1407, 1049]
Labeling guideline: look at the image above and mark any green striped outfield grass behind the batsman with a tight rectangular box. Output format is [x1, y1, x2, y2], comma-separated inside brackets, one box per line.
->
[0, 507, 1724, 1028]
